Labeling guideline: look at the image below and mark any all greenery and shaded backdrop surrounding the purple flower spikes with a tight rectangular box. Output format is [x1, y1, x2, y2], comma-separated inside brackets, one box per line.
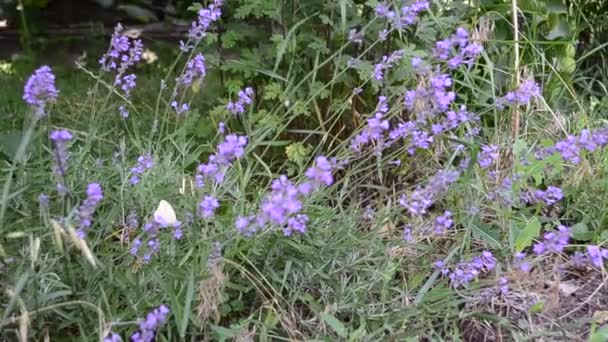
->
[0, 0, 608, 341]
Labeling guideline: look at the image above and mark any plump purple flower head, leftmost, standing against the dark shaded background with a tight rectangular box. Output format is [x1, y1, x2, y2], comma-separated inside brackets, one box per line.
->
[23, 65, 59, 118]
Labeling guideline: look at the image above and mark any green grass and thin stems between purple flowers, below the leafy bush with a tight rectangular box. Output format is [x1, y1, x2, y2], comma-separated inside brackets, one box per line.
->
[0, 1, 608, 341]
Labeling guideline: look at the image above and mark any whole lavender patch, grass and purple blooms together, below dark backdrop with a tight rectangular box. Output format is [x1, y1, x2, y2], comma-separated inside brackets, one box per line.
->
[0, 0, 608, 342]
